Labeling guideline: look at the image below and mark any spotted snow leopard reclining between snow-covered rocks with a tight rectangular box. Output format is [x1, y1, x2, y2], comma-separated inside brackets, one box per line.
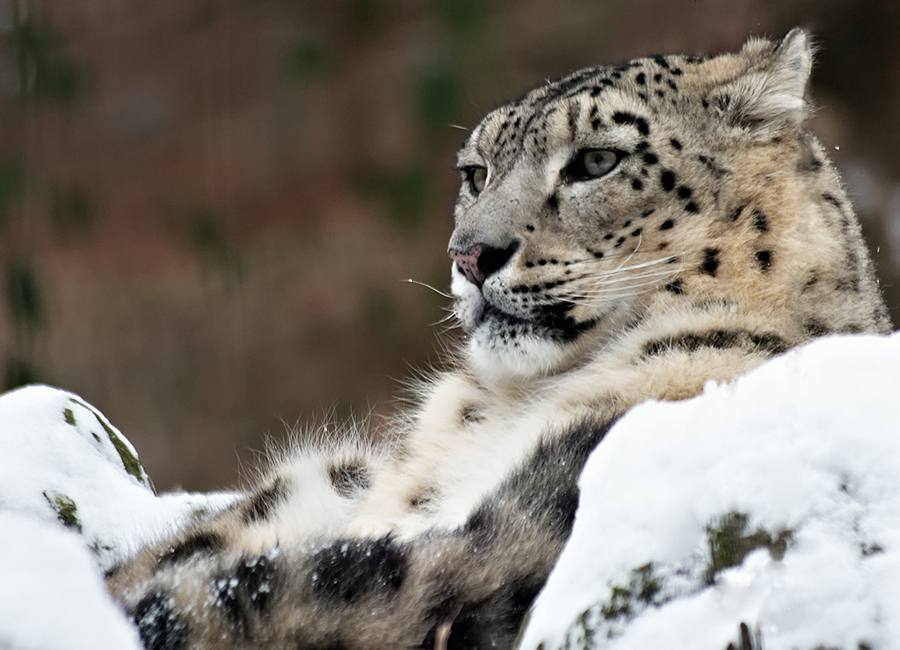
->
[107, 29, 891, 650]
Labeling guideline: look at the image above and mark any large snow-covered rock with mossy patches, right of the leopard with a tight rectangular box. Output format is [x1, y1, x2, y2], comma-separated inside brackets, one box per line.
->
[518, 334, 900, 650]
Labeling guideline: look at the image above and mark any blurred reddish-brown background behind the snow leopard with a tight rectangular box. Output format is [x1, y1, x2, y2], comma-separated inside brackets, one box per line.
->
[0, 0, 900, 489]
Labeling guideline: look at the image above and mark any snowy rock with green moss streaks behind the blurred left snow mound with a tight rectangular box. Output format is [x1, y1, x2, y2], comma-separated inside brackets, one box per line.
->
[0, 386, 233, 569]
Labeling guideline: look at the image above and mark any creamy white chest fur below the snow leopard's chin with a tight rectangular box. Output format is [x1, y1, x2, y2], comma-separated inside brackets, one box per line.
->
[349, 374, 600, 539]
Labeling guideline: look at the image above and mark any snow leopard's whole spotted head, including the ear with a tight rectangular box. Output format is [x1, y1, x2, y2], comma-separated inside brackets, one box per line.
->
[449, 37, 884, 379]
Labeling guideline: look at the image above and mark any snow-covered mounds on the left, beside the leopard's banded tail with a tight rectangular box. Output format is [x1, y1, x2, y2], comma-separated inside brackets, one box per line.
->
[0, 386, 234, 650]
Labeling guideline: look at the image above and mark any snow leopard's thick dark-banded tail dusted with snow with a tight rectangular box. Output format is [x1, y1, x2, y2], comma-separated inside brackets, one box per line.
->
[124, 416, 611, 650]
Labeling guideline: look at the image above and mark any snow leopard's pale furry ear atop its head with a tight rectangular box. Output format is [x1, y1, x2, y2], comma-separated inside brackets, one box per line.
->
[710, 28, 812, 140]
